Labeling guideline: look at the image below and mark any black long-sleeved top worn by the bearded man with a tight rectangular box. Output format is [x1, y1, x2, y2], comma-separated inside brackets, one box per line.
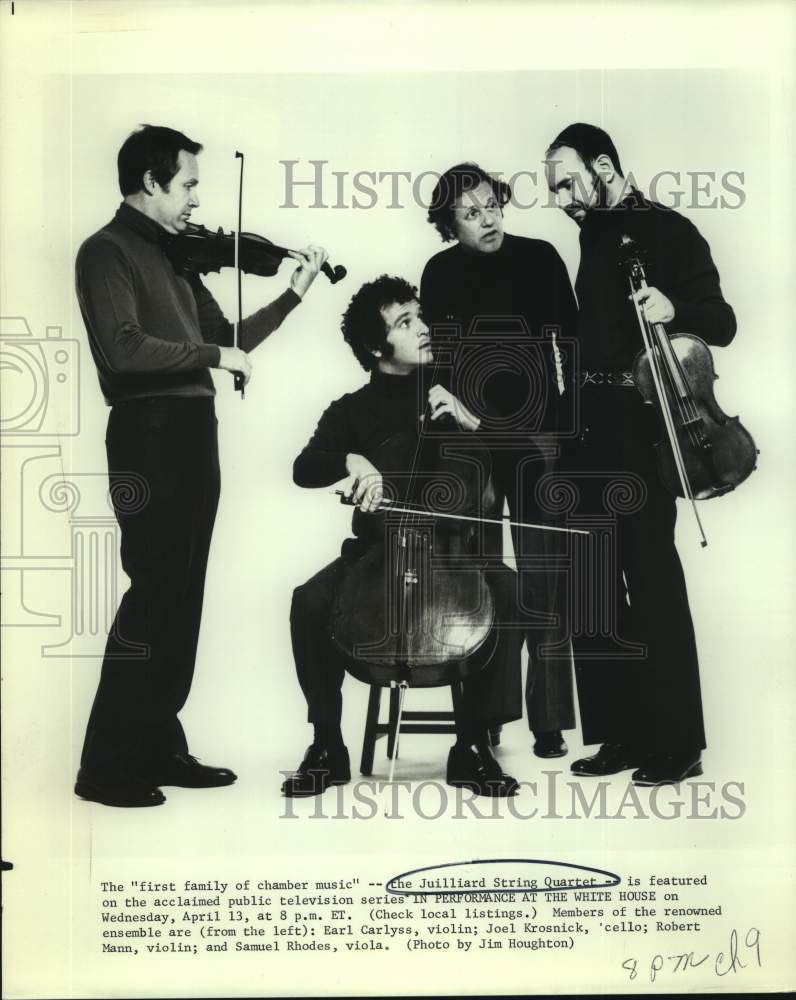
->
[575, 191, 735, 371]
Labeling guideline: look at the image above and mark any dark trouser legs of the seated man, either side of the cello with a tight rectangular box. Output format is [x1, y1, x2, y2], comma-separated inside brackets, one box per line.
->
[290, 558, 523, 730]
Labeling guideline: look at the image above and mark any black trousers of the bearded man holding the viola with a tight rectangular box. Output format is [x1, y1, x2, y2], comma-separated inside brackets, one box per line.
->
[566, 394, 705, 753]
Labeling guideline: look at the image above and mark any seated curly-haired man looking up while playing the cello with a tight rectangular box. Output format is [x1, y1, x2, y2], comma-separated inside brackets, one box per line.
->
[282, 275, 523, 796]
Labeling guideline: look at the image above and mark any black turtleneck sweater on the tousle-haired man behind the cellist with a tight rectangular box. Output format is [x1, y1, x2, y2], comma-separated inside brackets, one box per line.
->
[420, 234, 577, 431]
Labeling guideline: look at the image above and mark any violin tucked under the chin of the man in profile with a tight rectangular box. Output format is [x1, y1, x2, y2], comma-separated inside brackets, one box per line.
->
[167, 222, 348, 285]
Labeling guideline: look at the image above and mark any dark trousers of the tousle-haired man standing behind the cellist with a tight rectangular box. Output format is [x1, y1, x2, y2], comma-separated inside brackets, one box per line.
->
[488, 445, 575, 733]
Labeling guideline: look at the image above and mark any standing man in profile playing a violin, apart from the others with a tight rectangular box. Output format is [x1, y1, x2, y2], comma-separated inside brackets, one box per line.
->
[75, 125, 326, 806]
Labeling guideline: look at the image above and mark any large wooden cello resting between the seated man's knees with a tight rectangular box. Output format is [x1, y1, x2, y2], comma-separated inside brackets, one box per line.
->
[329, 378, 587, 780]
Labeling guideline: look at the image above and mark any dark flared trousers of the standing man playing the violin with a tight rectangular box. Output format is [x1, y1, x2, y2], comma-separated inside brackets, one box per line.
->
[81, 397, 220, 773]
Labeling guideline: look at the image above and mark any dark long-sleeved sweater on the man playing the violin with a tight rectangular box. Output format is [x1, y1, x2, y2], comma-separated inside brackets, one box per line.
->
[75, 202, 301, 405]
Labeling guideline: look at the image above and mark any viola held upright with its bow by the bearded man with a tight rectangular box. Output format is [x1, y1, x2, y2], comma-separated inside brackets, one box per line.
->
[620, 236, 758, 547]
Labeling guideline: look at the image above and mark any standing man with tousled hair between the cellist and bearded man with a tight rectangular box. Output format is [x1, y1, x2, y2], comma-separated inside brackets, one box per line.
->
[420, 163, 577, 757]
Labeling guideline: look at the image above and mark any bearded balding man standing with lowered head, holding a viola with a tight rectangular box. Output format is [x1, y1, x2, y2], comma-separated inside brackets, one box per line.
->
[545, 124, 735, 785]
